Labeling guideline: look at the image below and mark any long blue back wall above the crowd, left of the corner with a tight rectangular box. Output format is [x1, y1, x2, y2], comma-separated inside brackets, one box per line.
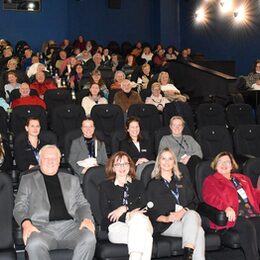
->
[0, 0, 180, 51]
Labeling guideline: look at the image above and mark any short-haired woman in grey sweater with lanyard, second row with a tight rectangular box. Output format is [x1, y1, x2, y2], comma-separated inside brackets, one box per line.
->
[159, 116, 202, 182]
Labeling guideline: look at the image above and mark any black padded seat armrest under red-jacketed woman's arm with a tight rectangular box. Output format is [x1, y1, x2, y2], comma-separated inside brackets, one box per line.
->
[197, 202, 228, 226]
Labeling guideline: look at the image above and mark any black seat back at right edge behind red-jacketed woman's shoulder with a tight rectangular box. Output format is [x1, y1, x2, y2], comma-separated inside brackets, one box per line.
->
[243, 158, 260, 188]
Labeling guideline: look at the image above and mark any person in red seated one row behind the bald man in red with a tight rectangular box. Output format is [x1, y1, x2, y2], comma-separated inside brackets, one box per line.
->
[30, 71, 57, 99]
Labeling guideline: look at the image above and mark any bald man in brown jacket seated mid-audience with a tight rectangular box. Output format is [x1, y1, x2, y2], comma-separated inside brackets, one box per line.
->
[114, 79, 143, 113]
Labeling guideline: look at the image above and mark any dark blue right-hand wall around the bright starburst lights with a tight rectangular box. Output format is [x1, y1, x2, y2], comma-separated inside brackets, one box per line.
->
[180, 0, 260, 75]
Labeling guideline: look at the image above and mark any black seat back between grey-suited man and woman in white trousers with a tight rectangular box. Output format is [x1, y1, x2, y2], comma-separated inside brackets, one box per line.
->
[82, 166, 106, 225]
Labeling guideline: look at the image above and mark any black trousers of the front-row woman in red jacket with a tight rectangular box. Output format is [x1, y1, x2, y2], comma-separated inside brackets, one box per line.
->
[233, 217, 260, 260]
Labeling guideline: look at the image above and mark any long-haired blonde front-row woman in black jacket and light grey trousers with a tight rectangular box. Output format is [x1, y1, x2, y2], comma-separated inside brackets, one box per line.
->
[147, 148, 205, 260]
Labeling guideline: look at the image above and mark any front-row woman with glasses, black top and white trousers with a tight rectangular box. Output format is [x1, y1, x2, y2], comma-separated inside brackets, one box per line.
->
[100, 151, 153, 260]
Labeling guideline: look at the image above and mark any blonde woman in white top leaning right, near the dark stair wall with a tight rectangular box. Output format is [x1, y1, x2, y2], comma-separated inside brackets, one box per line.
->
[158, 71, 187, 102]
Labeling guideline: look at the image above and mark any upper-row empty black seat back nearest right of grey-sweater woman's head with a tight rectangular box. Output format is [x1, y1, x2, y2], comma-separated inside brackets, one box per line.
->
[196, 103, 226, 128]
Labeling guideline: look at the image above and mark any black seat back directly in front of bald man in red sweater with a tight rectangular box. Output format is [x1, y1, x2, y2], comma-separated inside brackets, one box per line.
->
[11, 105, 47, 135]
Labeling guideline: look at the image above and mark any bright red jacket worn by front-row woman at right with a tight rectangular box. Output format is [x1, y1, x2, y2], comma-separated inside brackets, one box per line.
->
[202, 172, 260, 229]
